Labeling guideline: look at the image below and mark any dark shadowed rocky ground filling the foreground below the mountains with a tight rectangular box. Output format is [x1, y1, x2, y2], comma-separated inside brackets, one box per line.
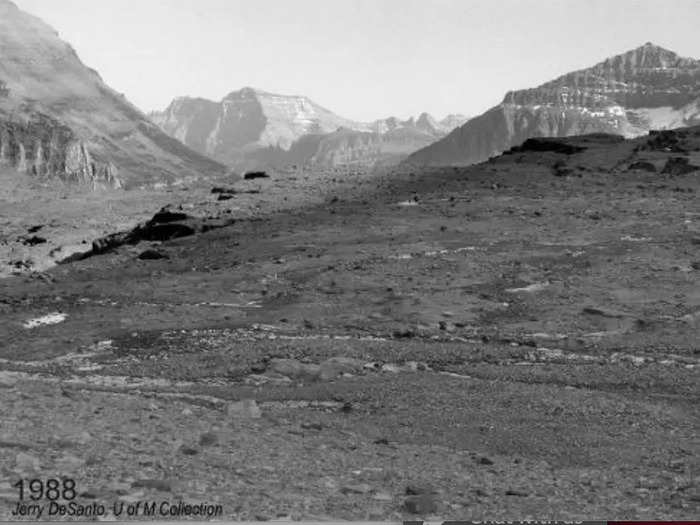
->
[0, 129, 700, 519]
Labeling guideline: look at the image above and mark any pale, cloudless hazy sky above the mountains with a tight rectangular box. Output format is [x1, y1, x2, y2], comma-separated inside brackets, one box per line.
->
[15, 0, 700, 120]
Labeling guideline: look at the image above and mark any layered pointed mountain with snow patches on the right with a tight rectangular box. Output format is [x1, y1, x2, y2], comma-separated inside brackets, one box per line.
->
[407, 43, 700, 165]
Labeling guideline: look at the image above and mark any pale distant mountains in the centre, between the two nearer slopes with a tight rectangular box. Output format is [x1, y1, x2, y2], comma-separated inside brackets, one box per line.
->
[149, 87, 467, 169]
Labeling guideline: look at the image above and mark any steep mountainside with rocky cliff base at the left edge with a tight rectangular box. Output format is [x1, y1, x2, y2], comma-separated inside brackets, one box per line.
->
[0, 0, 225, 187]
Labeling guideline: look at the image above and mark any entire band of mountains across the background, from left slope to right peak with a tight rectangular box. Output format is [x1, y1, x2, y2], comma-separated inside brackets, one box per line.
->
[0, 0, 700, 188]
